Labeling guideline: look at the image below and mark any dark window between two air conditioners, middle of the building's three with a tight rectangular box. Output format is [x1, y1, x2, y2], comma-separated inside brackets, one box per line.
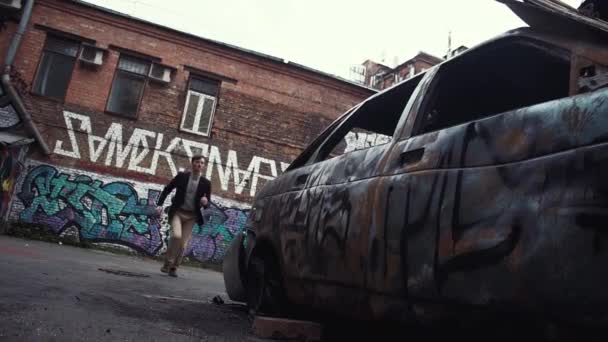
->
[107, 55, 151, 117]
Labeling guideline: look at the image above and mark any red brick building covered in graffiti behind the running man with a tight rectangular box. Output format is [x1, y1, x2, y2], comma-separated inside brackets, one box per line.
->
[0, 0, 374, 260]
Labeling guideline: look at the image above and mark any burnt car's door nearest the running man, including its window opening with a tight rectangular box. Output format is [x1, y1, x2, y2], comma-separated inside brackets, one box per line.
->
[282, 78, 426, 316]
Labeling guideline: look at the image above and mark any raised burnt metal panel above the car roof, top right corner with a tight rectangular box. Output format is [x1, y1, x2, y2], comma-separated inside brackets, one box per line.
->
[496, 0, 608, 34]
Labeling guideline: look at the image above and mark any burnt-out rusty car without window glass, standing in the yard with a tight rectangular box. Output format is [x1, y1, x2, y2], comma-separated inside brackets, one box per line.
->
[224, 0, 608, 328]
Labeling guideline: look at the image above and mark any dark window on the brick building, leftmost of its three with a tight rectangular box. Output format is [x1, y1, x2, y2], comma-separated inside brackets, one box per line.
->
[33, 35, 80, 100]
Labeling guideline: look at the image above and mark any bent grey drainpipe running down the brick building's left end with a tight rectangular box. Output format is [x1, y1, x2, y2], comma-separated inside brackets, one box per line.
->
[1, 0, 51, 156]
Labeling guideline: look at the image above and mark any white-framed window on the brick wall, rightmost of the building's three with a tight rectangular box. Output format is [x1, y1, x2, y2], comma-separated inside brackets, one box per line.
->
[181, 77, 219, 136]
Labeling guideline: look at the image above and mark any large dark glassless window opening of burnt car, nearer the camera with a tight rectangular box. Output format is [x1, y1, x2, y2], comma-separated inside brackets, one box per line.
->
[414, 37, 570, 134]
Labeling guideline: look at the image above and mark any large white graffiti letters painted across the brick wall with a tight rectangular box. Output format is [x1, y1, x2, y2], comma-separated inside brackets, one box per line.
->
[55, 112, 289, 197]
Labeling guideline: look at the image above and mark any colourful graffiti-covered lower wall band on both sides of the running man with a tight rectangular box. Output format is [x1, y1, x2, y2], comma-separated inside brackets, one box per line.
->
[9, 161, 248, 262]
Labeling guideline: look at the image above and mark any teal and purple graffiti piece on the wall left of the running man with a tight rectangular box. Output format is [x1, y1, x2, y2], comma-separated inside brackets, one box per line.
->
[17, 165, 163, 254]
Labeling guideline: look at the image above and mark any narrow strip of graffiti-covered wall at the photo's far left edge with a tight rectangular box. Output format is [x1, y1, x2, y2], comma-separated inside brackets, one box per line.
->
[0, 146, 27, 221]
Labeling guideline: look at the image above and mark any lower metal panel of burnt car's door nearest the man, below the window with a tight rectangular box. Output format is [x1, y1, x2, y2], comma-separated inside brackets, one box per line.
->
[275, 121, 387, 314]
